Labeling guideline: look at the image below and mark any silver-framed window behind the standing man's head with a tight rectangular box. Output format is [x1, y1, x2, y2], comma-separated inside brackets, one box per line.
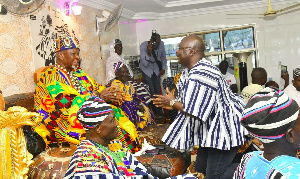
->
[162, 25, 257, 77]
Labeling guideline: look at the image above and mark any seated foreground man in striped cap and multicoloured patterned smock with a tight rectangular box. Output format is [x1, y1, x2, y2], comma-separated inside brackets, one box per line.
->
[64, 97, 195, 179]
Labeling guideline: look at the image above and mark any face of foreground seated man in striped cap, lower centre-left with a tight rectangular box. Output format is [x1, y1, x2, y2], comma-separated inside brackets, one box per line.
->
[100, 110, 119, 141]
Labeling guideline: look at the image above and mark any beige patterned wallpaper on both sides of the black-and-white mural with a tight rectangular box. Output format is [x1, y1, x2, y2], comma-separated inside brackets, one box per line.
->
[0, 3, 119, 97]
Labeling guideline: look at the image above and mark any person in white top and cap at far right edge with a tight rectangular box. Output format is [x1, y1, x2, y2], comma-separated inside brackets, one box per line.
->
[283, 68, 300, 106]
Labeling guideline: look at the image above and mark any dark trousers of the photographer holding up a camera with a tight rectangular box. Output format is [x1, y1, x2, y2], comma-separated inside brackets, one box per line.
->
[142, 72, 162, 116]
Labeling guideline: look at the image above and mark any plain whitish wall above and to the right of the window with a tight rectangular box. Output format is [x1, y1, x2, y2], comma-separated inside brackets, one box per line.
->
[120, 6, 300, 88]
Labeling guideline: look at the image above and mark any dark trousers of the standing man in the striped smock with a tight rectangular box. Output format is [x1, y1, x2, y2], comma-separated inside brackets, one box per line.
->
[195, 146, 239, 179]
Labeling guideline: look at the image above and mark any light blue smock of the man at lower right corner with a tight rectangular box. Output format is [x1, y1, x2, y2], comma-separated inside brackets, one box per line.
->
[233, 151, 300, 179]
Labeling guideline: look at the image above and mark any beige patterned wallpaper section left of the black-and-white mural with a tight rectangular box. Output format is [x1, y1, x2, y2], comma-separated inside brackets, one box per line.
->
[0, 14, 35, 97]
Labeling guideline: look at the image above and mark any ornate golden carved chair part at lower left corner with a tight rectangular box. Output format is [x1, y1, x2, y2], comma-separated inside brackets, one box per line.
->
[0, 106, 41, 179]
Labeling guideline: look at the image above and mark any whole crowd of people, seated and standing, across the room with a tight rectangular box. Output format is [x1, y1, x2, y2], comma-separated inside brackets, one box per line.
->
[10, 32, 300, 179]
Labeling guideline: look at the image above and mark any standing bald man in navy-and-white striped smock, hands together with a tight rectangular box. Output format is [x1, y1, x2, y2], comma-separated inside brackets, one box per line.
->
[153, 36, 246, 179]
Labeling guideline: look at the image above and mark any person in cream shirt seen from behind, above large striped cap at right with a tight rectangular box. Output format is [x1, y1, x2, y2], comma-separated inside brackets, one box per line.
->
[241, 68, 267, 102]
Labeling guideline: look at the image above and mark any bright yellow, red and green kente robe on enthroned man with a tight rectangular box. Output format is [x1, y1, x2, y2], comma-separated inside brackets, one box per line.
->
[34, 67, 105, 144]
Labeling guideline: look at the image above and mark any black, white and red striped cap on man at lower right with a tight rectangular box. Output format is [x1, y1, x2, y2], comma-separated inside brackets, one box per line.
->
[241, 87, 299, 143]
